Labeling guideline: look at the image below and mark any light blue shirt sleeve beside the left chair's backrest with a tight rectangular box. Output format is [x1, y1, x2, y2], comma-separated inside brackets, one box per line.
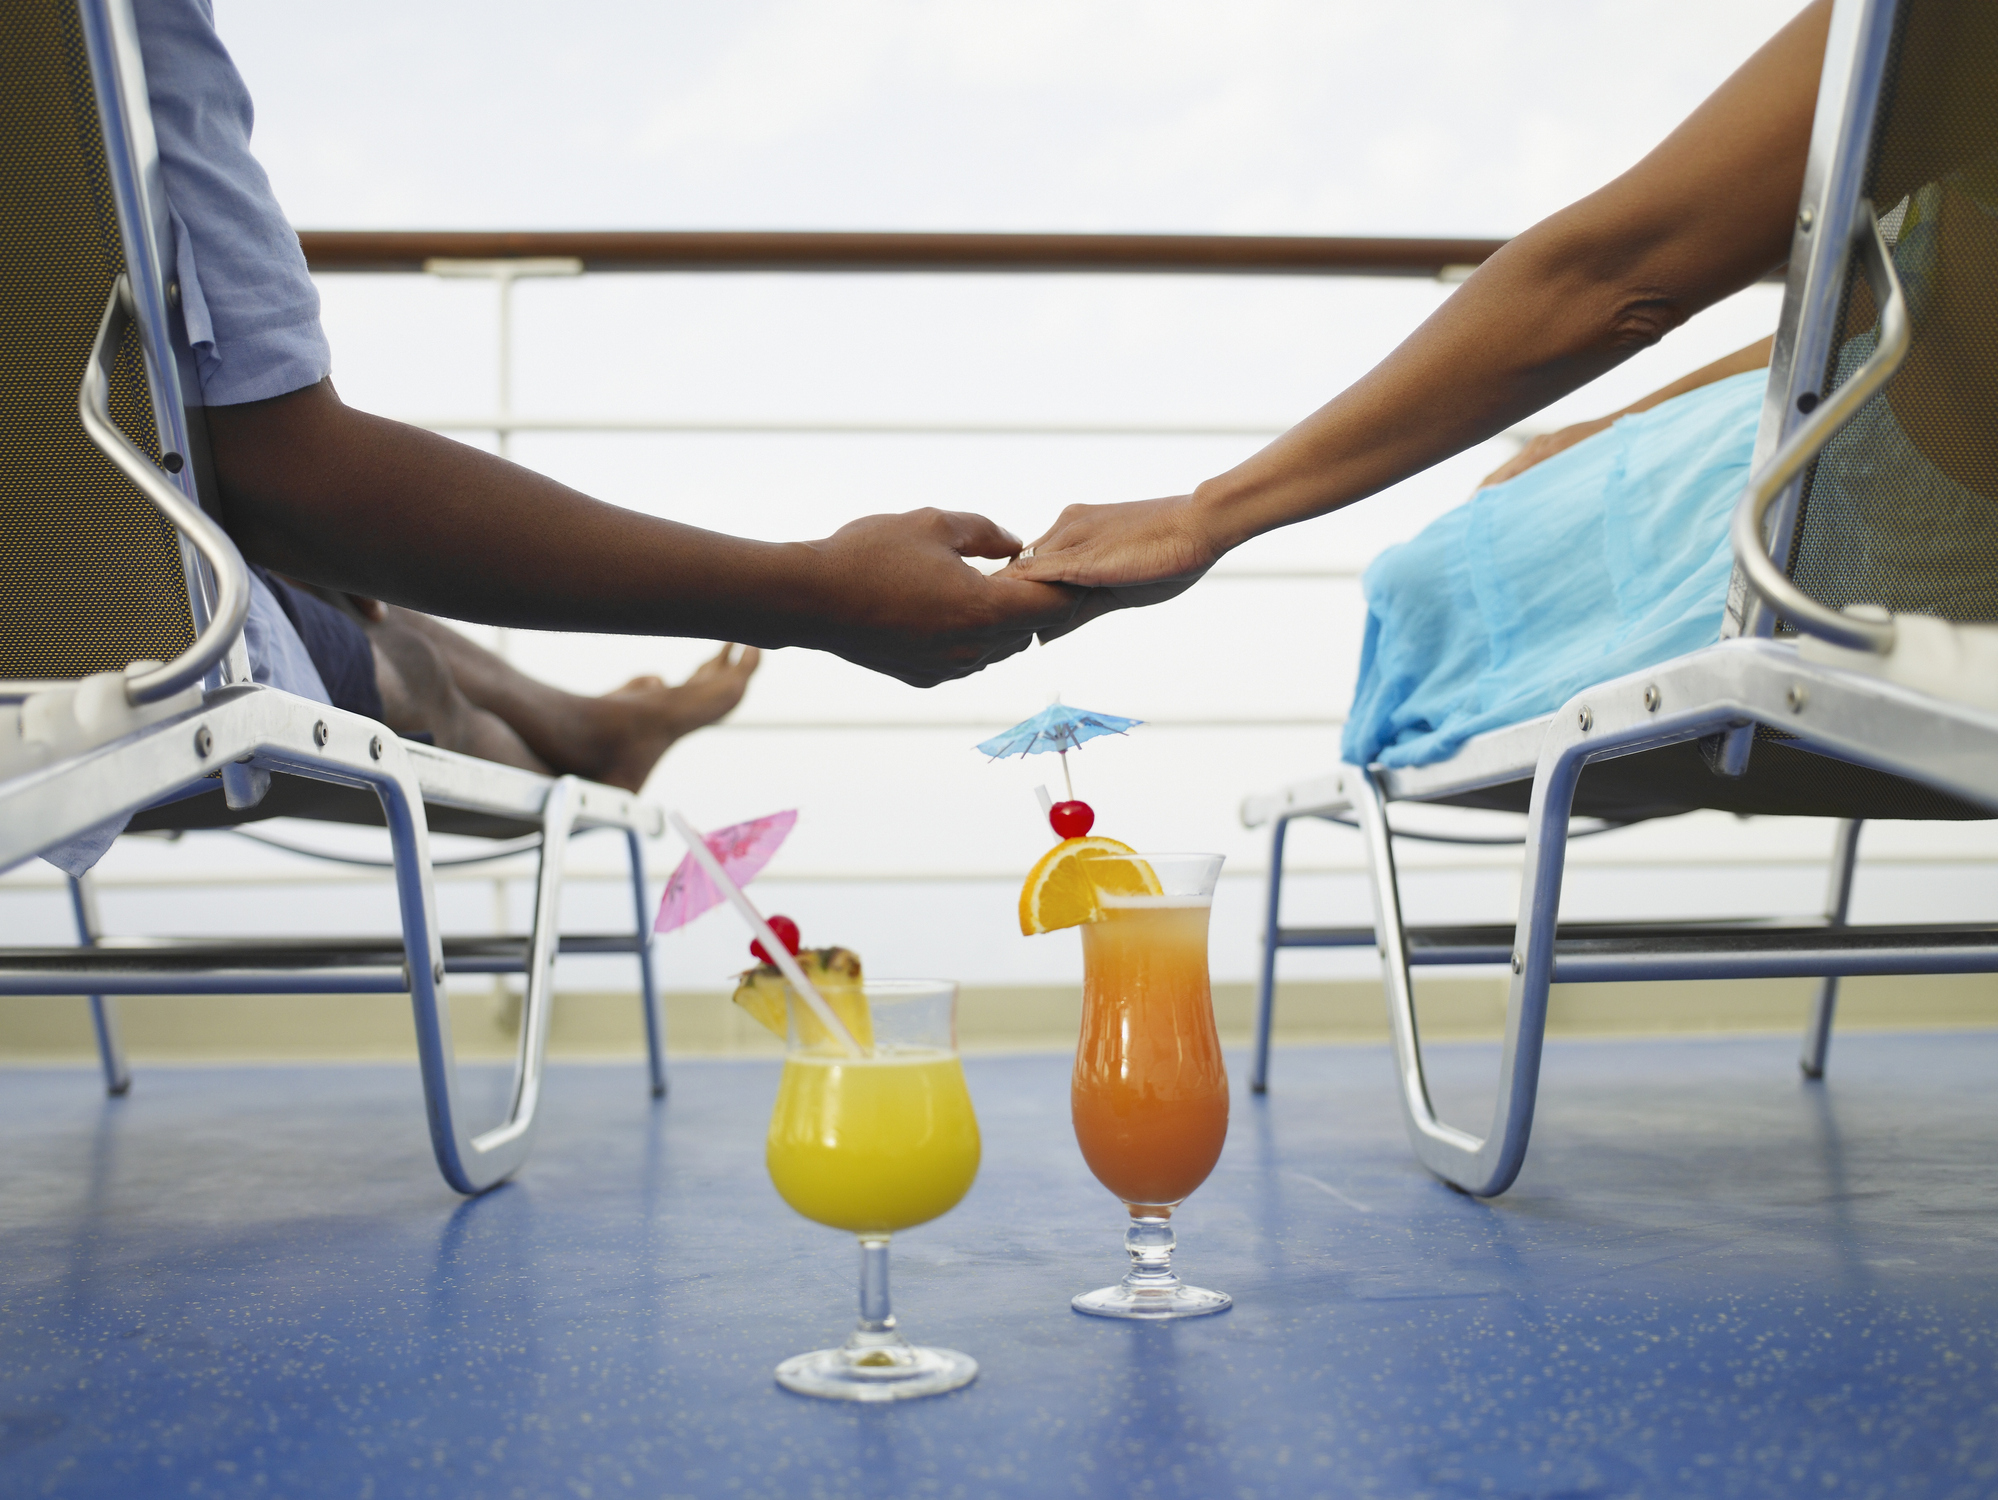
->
[132, 0, 334, 405]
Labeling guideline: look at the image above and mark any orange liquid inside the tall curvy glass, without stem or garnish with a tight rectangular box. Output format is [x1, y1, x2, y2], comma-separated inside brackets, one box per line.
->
[1069, 897, 1229, 1216]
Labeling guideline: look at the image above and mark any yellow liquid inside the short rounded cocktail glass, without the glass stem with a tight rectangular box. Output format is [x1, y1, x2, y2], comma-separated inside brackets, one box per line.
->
[765, 1049, 979, 1234]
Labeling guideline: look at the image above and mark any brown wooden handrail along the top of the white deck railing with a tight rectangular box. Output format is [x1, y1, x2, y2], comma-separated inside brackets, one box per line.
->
[298, 230, 1504, 276]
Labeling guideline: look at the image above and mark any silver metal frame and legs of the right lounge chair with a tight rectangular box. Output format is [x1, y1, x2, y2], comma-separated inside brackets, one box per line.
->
[1243, 0, 1998, 1196]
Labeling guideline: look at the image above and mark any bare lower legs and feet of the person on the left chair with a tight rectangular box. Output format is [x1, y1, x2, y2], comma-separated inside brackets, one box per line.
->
[364, 601, 761, 791]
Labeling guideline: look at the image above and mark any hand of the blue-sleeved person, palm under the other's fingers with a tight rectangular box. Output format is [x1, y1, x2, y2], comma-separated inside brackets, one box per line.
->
[801, 509, 1085, 687]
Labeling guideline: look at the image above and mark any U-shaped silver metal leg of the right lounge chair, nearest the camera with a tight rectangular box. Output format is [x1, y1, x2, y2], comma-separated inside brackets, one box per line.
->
[1349, 757, 1580, 1198]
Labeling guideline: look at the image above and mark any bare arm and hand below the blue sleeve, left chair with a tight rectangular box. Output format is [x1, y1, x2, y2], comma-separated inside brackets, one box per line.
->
[208, 379, 1079, 687]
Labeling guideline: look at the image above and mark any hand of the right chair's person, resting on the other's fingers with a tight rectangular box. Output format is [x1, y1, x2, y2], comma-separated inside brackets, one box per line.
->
[999, 495, 1225, 641]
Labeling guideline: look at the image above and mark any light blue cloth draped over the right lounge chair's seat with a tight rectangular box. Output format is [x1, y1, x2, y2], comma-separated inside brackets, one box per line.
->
[1343, 370, 1768, 765]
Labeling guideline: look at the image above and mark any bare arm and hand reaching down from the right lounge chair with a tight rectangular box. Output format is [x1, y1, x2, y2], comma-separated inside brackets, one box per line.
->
[1007, 0, 1830, 633]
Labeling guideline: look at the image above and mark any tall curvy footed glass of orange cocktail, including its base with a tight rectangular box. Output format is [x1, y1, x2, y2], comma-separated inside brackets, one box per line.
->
[1069, 853, 1231, 1318]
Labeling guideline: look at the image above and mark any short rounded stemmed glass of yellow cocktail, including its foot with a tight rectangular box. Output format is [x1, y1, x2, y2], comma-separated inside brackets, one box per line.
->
[765, 979, 979, 1402]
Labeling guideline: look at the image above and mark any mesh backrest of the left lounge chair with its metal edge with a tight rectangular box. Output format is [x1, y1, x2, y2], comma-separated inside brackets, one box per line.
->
[0, 0, 219, 693]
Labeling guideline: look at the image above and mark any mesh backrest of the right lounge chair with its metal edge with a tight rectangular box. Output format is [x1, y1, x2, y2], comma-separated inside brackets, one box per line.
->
[1726, 0, 1998, 635]
